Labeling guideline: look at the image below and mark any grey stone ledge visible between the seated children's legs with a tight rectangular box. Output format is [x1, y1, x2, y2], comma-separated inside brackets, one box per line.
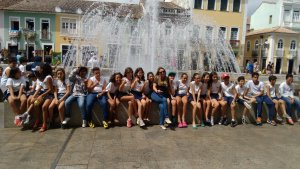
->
[0, 102, 296, 128]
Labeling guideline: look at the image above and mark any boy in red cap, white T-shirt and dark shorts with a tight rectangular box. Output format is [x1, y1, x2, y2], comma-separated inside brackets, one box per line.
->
[220, 73, 237, 127]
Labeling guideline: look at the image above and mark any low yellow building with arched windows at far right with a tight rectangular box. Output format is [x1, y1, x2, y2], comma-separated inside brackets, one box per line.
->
[244, 27, 300, 74]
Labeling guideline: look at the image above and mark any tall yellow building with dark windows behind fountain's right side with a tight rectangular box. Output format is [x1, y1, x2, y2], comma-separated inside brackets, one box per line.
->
[190, 0, 247, 66]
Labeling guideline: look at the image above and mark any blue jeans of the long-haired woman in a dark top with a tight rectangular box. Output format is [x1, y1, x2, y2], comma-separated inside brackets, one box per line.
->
[151, 92, 168, 125]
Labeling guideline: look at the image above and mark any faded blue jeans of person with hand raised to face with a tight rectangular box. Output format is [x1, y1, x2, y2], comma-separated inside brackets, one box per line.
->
[65, 95, 87, 120]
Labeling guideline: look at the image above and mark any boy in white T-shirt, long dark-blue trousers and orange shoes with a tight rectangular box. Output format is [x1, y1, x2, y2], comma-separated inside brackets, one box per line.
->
[245, 72, 277, 126]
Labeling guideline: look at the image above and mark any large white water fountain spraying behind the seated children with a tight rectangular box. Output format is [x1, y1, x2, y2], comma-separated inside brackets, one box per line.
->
[63, 0, 240, 73]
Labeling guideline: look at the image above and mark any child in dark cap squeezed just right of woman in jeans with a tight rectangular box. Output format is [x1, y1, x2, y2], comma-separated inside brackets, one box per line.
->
[168, 72, 177, 125]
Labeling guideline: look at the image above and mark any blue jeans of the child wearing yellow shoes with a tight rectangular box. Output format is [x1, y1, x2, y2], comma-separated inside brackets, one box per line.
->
[86, 93, 108, 121]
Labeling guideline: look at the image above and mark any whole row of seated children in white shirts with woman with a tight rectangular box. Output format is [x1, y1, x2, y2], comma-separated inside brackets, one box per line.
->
[1, 57, 300, 132]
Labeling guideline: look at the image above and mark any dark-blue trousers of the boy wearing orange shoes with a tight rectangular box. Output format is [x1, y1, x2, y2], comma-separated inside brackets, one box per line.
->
[256, 95, 275, 120]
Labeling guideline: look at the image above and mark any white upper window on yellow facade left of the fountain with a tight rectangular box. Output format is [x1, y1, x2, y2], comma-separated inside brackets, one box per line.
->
[60, 18, 77, 35]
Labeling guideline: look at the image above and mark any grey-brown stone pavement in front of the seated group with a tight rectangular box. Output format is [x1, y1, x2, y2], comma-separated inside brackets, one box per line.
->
[0, 124, 300, 169]
